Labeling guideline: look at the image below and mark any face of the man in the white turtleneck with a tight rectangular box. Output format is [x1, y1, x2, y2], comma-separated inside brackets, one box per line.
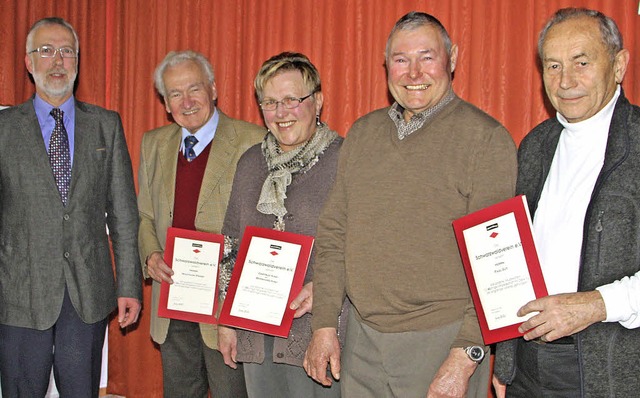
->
[542, 17, 629, 123]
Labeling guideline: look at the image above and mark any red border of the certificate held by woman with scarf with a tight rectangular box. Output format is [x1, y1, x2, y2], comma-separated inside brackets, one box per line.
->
[219, 226, 314, 338]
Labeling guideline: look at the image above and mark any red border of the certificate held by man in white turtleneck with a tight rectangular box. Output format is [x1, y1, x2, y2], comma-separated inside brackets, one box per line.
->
[453, 195, 548, 345]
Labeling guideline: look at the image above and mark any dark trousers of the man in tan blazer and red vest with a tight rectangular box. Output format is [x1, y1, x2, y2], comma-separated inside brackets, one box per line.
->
[160, 319, 247, 398]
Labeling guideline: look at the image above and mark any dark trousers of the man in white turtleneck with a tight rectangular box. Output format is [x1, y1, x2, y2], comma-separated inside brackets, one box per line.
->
[507, 339, 580, 398]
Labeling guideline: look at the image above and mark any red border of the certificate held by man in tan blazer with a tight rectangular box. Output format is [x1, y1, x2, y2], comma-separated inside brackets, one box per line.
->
[158, 227, 224, 324]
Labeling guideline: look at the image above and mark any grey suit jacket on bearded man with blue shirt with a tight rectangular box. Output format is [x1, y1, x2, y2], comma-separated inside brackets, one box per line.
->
[0, 99, 142, 330]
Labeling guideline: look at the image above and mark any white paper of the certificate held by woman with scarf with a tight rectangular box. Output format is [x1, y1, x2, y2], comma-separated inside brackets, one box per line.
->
[230, 236, 301, 325]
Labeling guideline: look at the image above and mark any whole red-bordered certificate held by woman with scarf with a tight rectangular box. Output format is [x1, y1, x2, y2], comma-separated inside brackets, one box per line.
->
[219, 226, 314, 337]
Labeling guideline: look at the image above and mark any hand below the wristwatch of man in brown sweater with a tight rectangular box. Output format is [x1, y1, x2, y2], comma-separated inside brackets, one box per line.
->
[427, 348, 478, 398]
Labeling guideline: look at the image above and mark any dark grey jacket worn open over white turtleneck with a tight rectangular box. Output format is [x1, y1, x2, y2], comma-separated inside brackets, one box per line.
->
[494, 91, 640, 397]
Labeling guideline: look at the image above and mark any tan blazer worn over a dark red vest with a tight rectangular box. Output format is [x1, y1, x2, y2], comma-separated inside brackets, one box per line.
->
[138, 109, 266, 348]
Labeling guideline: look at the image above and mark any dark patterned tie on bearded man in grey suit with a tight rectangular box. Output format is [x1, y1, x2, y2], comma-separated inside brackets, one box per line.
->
[49, 108, 71, 206]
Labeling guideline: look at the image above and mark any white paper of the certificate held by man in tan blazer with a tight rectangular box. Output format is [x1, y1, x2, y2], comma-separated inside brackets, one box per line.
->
[167, 237, 220, 315]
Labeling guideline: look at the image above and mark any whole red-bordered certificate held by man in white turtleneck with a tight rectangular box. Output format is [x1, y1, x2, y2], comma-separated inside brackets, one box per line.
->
[453, 195, 547, 344]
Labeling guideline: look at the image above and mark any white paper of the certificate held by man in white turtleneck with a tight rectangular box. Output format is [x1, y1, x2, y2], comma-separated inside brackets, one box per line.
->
[463, 213, 536, 330]
